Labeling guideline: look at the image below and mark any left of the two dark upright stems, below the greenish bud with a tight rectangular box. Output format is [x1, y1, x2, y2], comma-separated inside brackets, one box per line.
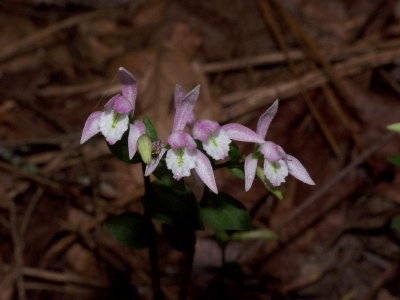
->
[142, 163, 164, 300]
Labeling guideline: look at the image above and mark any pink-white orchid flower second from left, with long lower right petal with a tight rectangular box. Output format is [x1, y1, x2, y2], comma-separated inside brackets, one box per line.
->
[145, 86, 218, 193]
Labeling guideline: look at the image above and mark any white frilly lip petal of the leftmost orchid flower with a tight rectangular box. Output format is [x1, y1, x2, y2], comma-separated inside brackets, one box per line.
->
[99, 110, 129, 145]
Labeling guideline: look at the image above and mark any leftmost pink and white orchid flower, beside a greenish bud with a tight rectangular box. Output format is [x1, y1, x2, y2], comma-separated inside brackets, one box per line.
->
[81, 67, 146, 158]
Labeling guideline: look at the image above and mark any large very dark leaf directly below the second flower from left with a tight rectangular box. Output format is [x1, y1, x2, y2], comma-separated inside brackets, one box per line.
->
[143, 181, 203, 230]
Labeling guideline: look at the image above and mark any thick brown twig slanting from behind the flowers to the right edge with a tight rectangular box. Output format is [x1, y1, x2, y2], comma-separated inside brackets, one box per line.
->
[220, 49, 400, 122]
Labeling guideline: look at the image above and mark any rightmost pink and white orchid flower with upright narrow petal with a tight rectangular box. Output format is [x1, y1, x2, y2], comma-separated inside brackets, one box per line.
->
[244, 100, 315, 191]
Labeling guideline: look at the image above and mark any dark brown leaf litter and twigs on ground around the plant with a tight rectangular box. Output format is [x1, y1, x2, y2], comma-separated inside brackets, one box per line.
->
[0, 0, 400, 300]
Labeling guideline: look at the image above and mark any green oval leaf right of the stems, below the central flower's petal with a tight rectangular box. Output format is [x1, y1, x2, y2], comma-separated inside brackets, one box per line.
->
[200, 193, 251, 230]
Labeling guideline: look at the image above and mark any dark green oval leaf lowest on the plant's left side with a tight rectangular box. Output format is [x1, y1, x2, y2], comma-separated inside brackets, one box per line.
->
[106, 212, 154, 249]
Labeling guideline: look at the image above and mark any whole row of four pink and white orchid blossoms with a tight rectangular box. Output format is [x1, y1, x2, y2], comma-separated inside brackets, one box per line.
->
[81, 68, 315, 193]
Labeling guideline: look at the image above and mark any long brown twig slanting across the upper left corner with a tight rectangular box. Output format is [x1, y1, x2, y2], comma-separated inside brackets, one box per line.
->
[0, 10, 105, 61]
